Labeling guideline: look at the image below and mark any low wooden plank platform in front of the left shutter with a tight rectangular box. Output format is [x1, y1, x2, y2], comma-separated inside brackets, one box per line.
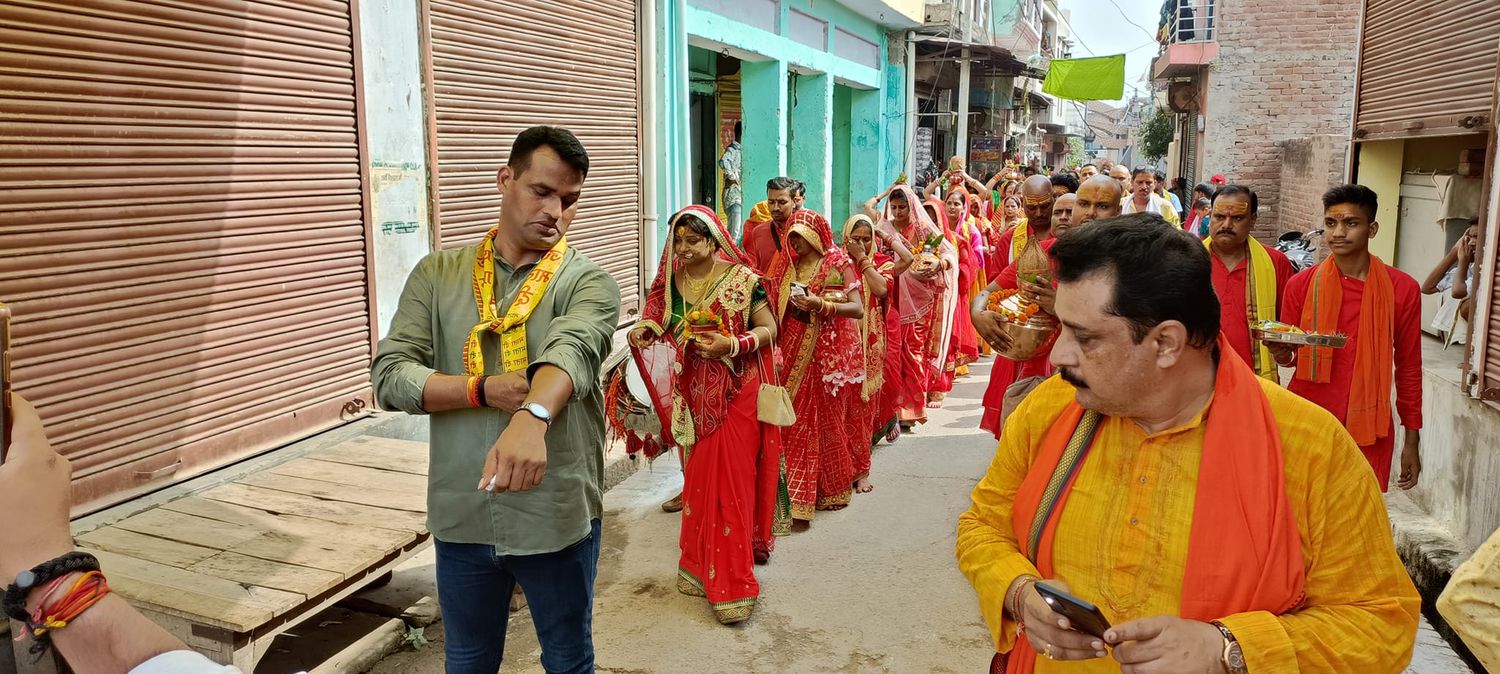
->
[18, 437, 431, 672]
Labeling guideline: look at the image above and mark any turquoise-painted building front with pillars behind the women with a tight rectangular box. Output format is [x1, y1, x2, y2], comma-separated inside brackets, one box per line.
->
[644, 0, 906, 255]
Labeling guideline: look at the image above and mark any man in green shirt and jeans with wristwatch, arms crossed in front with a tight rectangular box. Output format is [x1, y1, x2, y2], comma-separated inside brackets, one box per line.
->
[372, 126, 620, 674]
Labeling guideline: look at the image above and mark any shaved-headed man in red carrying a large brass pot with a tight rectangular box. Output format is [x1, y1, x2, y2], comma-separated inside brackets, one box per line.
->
[969, 176, 1056, 437]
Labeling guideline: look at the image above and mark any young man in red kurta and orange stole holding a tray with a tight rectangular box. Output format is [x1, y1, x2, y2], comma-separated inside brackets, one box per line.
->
[1271, 185, 1422, 491]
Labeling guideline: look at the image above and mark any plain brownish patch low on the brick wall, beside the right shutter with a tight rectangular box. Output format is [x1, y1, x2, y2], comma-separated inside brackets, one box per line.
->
[1278, 135, 1349, 240]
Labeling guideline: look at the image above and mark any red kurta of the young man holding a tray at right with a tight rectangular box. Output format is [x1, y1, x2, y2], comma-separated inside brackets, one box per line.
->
[1281, 267, 1422, 491]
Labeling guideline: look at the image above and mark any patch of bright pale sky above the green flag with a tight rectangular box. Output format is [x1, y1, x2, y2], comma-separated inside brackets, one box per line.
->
[1062, 0, 1161, 104]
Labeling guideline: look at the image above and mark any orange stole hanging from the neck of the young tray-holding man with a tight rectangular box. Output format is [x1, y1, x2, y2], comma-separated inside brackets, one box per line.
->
[1296, 255, 1397, 446]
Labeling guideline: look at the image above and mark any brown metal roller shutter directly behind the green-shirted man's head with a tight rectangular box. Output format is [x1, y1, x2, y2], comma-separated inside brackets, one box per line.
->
[428, 0, 641, 309]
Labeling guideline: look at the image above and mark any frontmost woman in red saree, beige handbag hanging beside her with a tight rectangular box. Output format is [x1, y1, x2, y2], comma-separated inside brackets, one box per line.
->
[629, 206, 785, 624]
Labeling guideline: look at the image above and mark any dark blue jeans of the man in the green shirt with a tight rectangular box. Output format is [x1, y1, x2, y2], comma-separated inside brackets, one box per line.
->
[437, 519, 599, 674]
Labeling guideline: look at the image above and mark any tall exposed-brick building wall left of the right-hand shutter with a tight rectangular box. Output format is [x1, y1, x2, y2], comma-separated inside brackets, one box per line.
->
[1199, 0, 1361, 240]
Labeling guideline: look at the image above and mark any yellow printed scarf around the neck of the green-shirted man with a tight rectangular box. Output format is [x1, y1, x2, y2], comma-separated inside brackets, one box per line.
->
[464, 225, 567, 377]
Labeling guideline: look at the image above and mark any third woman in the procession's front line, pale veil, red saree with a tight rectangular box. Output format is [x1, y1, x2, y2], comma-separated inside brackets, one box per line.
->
[843, 215, 912, 494]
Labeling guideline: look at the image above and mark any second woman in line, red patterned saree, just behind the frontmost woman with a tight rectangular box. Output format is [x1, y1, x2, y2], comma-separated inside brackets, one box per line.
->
[767, 210, 864, 522]
